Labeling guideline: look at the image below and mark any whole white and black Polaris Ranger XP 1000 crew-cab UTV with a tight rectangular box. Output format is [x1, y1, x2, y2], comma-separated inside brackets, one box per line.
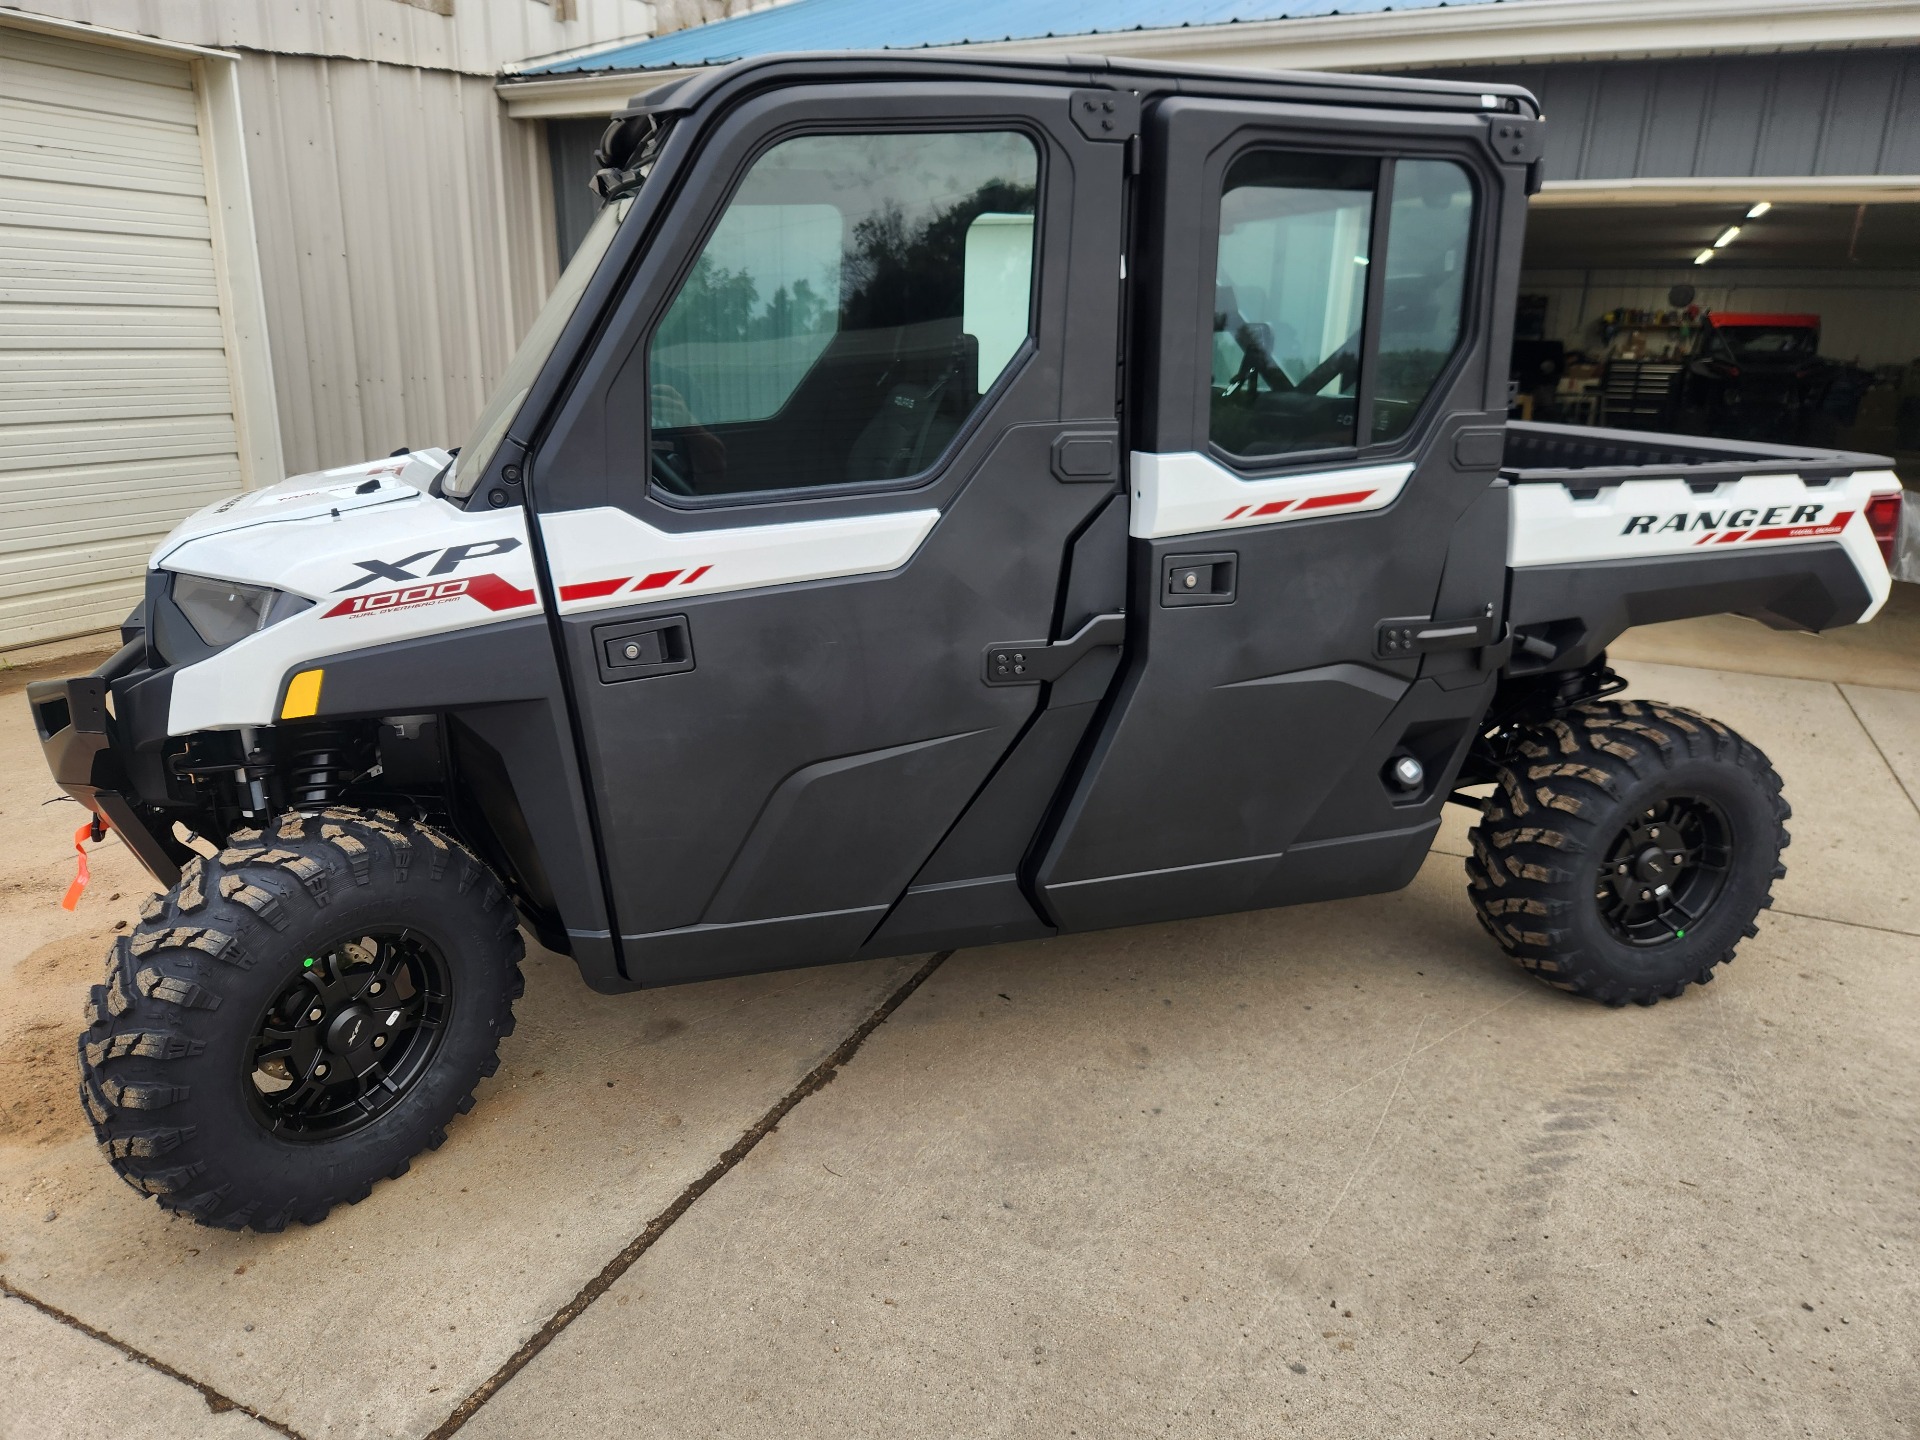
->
[31, 56, 1899, 1231]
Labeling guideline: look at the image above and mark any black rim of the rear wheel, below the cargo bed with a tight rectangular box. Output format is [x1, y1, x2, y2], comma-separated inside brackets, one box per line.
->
[1594, 795, 1734, 948]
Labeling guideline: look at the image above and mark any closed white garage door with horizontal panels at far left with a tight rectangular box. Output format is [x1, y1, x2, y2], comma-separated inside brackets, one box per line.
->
[0, 27, 242, 647]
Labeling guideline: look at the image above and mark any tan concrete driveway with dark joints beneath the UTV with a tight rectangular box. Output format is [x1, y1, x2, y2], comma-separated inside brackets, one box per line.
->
[0, 628, 1920, 1440]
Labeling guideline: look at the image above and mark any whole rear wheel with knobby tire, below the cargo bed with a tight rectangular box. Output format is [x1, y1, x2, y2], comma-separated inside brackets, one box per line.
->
[1467, 701, 1791, 1006]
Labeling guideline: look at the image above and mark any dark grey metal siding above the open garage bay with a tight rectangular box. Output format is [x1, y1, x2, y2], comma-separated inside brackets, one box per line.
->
[1405, 48, 1920, 180]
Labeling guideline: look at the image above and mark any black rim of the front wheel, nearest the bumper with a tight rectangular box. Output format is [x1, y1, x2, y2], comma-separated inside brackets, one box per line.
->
[244, 927, 453, 1140]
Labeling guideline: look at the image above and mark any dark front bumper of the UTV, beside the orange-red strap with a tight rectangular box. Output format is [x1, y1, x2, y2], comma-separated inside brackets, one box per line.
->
[27, 636, 180, 889]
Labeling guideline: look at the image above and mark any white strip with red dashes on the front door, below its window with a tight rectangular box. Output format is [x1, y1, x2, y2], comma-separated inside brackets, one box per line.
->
[540, 505, 941, 614]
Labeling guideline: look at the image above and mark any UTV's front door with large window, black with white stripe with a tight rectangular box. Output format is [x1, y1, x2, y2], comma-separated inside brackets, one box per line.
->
[532, 83, 1125, 983]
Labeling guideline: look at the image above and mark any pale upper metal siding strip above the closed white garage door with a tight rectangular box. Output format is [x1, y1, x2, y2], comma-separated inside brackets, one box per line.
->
[17, 0, 668, 75]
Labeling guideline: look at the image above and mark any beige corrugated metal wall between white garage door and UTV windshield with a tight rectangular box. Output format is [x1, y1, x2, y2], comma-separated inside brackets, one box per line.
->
[240, 54, 553, 474]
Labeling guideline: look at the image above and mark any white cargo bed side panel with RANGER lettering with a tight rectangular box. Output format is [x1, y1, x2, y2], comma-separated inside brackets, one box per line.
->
[1507, 470, 1901, 622]
